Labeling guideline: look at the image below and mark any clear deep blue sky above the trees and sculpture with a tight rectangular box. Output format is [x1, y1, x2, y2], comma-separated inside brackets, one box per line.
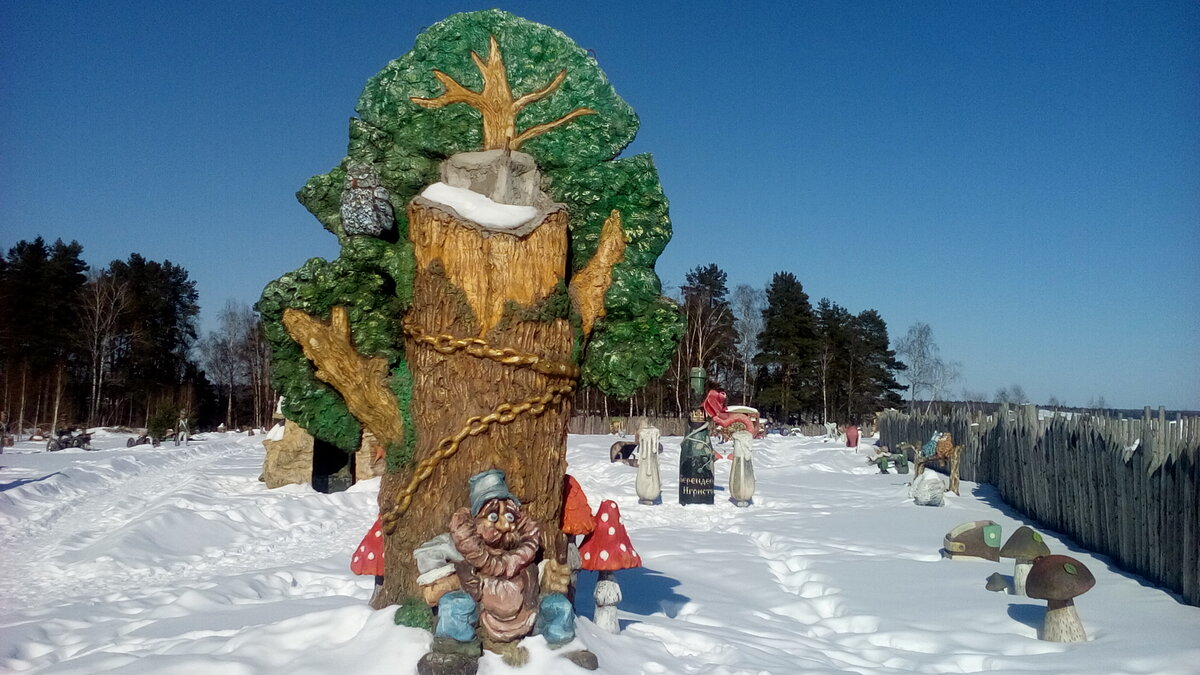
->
[0, 0, 1200, 410]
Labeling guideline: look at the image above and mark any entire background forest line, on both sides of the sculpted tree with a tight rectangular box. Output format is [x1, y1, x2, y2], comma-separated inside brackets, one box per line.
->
[0, 237, 926, 429]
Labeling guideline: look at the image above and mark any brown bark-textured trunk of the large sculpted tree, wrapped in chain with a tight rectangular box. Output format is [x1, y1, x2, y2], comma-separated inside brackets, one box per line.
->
[372, 198, 575, 608]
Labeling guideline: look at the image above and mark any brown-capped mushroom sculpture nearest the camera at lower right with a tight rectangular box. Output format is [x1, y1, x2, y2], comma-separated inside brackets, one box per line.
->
[1025, 555, 1096, 643]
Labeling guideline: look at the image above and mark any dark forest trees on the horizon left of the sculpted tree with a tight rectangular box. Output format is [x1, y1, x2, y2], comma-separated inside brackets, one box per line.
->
[0, 237, 274, 430]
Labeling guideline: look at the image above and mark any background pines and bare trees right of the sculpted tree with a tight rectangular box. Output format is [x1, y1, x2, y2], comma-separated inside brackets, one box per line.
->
[576, 264, 907, 424]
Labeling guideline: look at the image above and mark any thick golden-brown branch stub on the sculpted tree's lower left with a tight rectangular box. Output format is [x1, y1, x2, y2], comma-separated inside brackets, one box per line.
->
[283, 306, 404, 446]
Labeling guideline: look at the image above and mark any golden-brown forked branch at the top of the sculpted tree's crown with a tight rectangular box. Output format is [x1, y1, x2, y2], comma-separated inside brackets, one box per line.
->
[409, 36, 595, 150]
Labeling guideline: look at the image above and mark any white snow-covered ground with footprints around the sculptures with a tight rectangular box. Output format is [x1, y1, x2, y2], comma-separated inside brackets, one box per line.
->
[0, 432, 1200, 675]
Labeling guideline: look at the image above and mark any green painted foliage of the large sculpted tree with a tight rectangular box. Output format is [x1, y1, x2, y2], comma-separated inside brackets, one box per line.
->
[257, 10, 683, 450]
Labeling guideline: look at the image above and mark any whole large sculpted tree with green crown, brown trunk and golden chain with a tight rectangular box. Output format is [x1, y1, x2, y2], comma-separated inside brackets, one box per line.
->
[258, 10, 682, 607]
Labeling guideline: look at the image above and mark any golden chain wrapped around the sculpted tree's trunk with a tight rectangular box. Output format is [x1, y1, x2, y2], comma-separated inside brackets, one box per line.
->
[382, 319, 580, 534]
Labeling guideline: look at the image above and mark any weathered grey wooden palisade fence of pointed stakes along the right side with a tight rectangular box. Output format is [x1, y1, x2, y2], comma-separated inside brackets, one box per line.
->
[880, 406, 1200, 605]
